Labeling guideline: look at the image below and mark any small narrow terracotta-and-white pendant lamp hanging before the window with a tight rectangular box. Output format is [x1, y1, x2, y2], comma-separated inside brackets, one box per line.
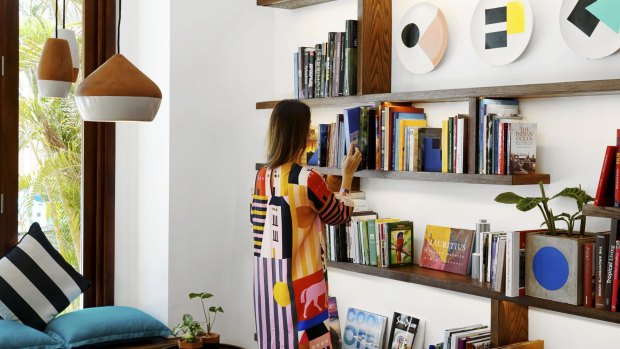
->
[37, 38, 73, 98]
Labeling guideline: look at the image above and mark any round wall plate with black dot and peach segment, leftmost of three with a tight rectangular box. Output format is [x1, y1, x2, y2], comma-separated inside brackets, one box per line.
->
[394, 2, 448, 74]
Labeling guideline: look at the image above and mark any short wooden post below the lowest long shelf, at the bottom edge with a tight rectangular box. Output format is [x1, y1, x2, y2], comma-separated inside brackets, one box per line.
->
[491, 299, 528, 348]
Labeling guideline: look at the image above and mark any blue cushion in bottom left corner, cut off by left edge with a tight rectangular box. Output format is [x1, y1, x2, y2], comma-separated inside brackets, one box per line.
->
[0, 320, 61, 349]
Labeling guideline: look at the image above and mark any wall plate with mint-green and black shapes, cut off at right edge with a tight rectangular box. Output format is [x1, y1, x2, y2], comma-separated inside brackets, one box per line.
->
[560, 0, 620, 59]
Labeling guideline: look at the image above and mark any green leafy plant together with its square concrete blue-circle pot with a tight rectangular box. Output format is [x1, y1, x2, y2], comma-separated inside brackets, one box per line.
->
[495, 182, 595, 305]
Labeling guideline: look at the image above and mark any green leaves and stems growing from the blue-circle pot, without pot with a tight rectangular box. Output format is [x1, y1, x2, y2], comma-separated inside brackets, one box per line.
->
[495, 182, 594, 236]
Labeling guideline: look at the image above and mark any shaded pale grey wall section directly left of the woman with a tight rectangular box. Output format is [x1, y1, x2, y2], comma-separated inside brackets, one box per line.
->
[169, 0, 273, 347]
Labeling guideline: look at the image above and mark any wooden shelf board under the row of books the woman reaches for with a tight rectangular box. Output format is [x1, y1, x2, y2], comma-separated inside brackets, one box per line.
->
[256, 164, 551, 185]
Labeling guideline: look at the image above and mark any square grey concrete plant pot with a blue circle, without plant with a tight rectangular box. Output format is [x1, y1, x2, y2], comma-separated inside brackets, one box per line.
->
[525, 233, 596, 305]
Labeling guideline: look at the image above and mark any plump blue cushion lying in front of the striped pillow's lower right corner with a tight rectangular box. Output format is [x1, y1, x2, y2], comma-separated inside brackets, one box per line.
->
[45, 306, 172, 348]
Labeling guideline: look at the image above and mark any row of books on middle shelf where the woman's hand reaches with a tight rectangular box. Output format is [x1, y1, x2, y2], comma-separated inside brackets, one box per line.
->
[307, 102, 537, 175]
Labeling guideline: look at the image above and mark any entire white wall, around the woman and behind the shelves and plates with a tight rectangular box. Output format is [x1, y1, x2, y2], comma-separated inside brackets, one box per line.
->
[116, 0, 620, 349]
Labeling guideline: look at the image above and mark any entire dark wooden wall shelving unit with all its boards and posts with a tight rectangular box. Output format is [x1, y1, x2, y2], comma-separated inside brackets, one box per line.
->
[256, 0, 620, 347]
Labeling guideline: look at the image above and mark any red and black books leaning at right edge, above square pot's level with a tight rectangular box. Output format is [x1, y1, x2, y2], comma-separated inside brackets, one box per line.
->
[594, 129, 620, 207]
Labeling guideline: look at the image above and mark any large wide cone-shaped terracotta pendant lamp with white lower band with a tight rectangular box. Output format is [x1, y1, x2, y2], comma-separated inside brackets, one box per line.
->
[75, 54, 161, 122]
